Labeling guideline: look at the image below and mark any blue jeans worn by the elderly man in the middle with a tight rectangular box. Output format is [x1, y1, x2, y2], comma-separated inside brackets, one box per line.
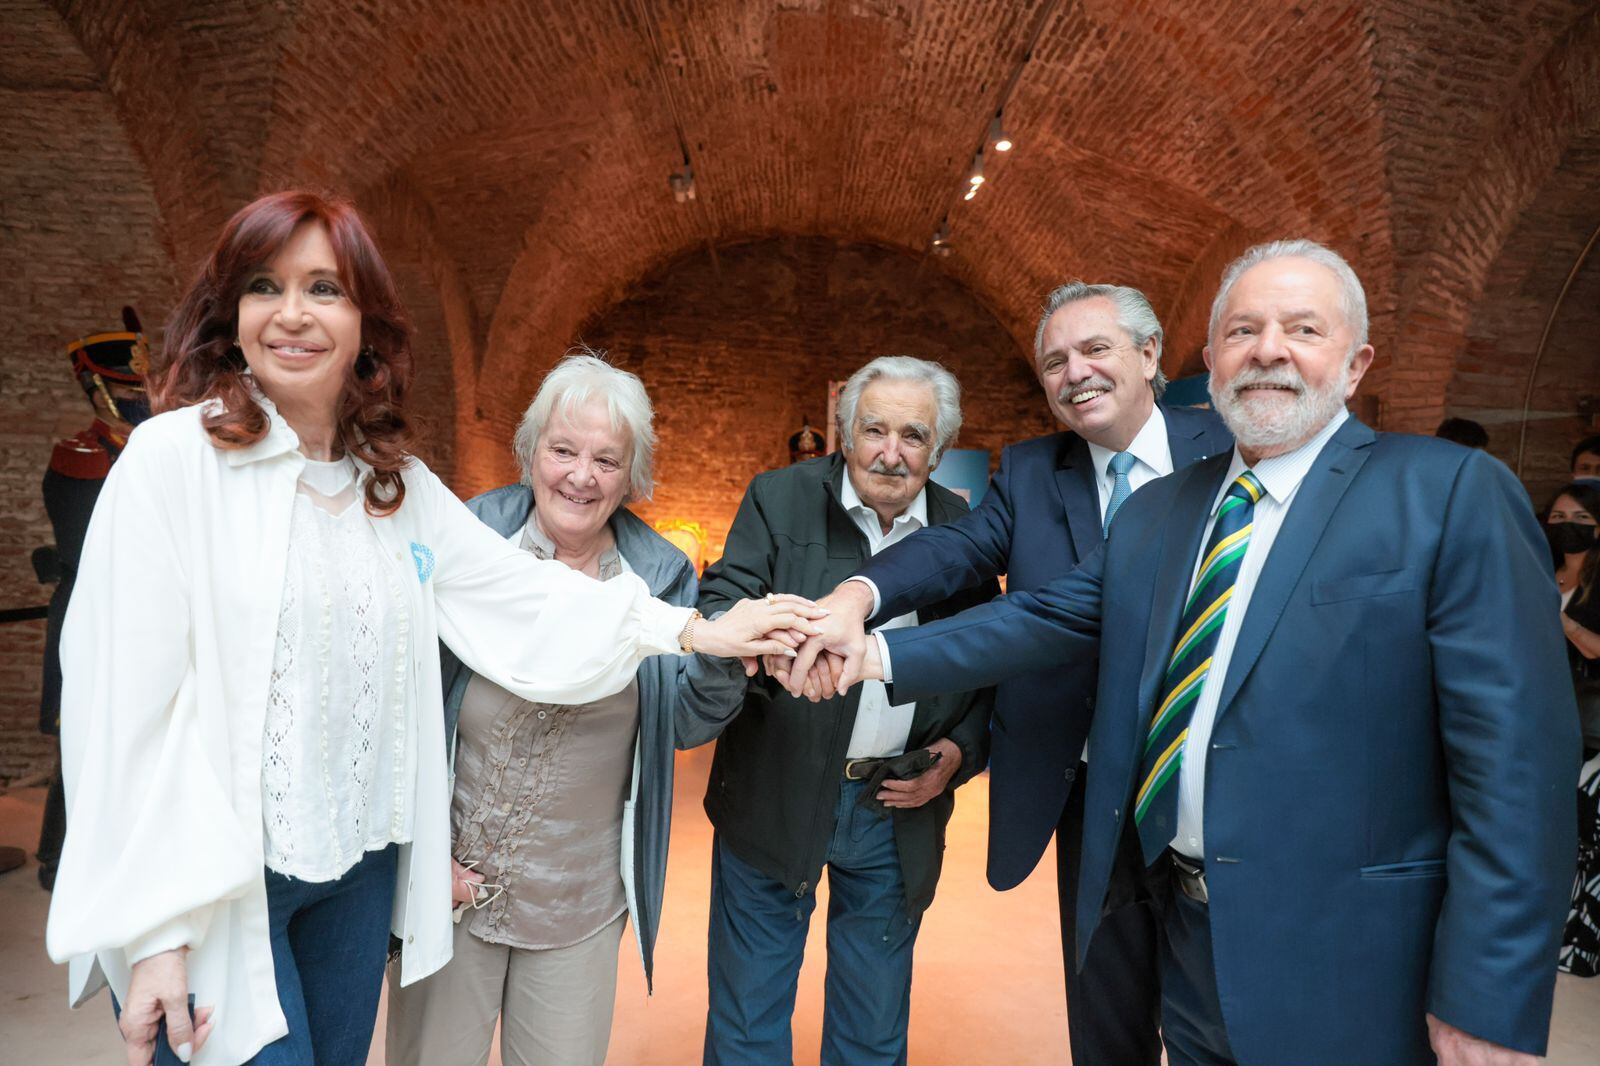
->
[704, 781, 920, 1066]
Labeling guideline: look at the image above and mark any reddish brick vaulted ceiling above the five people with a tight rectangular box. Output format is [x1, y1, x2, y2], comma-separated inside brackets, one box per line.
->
[15, 0, 1600, 486]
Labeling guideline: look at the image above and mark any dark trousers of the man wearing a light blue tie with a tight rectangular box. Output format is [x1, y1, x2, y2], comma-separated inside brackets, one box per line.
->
[1056, 763, 1162, 1066]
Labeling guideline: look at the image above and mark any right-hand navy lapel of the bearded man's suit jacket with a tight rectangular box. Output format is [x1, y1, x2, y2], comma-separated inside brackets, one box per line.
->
[1216, 418, 1376, 719]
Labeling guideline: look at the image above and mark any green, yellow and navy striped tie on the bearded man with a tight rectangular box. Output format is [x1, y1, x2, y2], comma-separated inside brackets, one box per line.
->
[1133, 471, 1266, 864]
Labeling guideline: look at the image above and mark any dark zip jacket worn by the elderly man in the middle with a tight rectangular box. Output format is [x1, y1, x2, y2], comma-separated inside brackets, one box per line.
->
[699, 453, 998, 916]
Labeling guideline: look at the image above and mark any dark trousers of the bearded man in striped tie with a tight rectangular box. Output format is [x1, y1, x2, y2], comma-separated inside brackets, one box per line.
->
[1160, 856, 1234, 1066]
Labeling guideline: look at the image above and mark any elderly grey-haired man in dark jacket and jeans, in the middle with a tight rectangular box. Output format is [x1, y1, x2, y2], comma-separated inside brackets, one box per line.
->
[699, 355, 998, 1066]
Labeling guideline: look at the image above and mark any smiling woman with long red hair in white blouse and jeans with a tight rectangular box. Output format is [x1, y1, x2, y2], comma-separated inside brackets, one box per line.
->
[48, 192, 819, 1066]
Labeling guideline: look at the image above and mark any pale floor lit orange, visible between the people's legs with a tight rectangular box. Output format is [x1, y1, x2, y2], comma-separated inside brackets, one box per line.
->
[0, 749, 1600, 1066]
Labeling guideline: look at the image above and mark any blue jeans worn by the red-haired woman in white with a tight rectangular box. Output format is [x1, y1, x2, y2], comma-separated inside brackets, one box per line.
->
[112, 844, 398, 1066]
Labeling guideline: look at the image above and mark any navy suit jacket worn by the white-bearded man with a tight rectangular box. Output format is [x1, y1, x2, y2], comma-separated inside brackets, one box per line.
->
[885, 419, 1579, 1066]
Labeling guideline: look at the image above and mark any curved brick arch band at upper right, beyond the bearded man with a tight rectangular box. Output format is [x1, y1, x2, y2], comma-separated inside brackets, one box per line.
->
[1384, 11, 1600, 432]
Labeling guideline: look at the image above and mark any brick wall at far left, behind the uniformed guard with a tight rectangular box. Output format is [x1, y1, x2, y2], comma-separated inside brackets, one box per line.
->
[0, 62, 174, 779]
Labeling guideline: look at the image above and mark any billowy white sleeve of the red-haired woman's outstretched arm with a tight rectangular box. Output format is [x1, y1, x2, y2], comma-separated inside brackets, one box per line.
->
[416, 474, 690, 704]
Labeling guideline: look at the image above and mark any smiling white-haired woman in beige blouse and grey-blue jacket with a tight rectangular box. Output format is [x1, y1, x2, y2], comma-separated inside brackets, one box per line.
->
[387, 354, 768, 1066]
